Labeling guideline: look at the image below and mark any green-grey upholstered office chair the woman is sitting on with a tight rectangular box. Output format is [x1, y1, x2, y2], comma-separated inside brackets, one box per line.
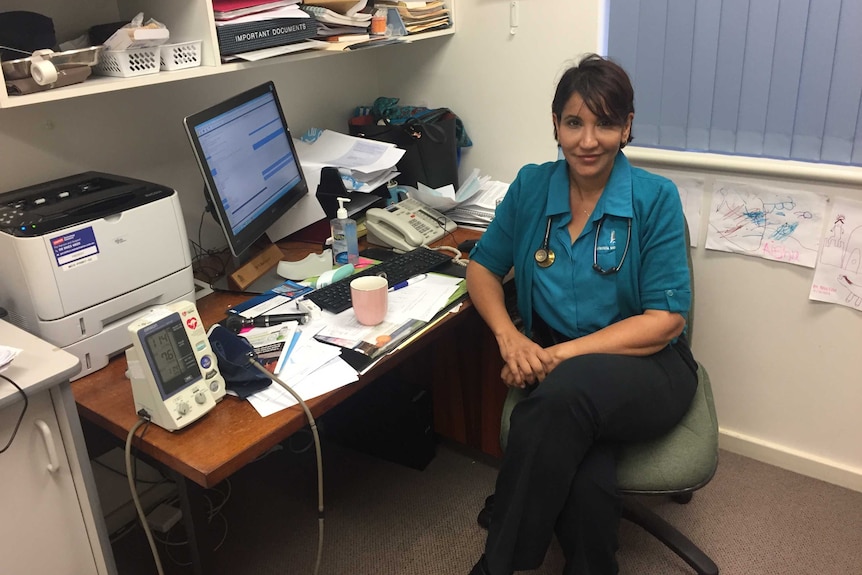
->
[477, 225, 718, 575]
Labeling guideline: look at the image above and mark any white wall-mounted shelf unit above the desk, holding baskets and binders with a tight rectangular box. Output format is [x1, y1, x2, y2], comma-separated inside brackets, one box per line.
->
[0, 0, 455, 108]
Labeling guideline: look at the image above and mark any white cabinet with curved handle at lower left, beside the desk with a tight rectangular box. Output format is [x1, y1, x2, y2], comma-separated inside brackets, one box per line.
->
[0, 321, 116, 575]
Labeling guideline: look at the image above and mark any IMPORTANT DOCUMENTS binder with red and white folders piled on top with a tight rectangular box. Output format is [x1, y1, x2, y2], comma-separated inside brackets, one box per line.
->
[212, 0, 317, 59]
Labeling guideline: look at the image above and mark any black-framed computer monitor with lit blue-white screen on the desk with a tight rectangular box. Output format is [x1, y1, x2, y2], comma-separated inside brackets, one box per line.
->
[184, 82, 308, 259]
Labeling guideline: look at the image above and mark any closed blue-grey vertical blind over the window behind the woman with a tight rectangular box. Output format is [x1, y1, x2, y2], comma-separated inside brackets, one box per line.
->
[607, 0, 862, 166]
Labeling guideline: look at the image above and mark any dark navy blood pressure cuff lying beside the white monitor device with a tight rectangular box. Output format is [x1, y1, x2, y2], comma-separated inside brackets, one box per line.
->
[207, 324, 272, 399]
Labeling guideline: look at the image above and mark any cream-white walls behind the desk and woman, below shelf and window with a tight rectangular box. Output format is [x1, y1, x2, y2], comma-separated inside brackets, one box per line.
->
[0, 0, 862, 491]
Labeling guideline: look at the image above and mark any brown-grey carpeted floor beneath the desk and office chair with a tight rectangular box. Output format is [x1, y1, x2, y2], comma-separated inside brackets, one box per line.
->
[114, 437, 862, 575]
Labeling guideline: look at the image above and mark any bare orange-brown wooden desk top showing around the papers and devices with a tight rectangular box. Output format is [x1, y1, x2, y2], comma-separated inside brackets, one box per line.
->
[72, 231, 490, 487]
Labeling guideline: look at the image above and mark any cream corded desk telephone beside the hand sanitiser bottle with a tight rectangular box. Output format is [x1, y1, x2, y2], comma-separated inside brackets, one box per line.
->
[365, 198, 458, 251]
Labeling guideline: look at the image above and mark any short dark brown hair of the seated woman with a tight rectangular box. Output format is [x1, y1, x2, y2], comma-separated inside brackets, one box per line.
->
[551, 54, 635, 143]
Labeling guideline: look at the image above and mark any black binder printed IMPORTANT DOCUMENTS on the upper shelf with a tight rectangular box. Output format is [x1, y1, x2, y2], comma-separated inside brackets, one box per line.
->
[216, 18, 317, 56]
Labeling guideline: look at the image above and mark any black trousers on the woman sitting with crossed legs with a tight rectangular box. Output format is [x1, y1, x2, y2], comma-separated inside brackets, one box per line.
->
[485, 339, 697, 575]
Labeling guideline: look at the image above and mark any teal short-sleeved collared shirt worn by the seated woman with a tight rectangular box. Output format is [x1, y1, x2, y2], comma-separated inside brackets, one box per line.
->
[470, 152, 691, 337]
